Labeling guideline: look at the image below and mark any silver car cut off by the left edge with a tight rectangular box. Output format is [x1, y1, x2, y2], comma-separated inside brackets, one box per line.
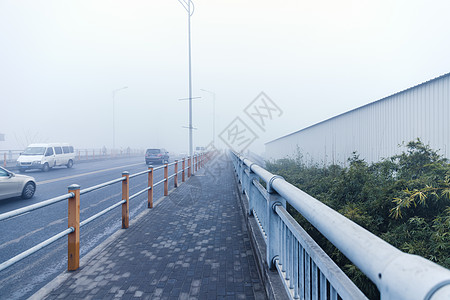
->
[0, 167, 36, 200]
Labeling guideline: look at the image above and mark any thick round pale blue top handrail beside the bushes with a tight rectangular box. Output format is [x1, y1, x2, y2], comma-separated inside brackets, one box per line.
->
[232, 152, 450, 299]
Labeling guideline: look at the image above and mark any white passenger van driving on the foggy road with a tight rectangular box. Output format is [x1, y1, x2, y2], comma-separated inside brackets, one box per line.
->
[16, 143, 75, 172]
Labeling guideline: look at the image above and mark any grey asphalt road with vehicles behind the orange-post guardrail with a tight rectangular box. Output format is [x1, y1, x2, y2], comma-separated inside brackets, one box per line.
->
[0, 157, 178, 299]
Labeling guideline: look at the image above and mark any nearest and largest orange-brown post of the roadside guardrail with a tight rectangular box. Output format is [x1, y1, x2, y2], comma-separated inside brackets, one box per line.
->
[67, 184, 80, 271]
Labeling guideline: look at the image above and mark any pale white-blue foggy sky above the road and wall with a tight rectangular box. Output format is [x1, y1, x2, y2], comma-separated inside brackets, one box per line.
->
[0, 0, 450, 153]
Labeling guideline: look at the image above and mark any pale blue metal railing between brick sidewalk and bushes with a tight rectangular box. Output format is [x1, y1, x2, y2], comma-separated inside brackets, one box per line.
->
[231, 152, 450, 299]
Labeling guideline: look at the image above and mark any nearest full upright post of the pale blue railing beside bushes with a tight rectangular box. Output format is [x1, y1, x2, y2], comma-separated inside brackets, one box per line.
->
[266, 175, 286, 269]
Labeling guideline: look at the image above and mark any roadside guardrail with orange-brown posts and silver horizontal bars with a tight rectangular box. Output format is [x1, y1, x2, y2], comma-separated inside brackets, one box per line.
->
[0, 153, 209, 271]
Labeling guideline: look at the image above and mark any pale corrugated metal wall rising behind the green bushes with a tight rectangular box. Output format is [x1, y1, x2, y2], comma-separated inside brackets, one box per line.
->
[266, 73, 450, 165]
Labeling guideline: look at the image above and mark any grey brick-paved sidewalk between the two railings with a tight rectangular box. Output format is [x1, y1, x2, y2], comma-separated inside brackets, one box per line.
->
[34, 156, 265, 299]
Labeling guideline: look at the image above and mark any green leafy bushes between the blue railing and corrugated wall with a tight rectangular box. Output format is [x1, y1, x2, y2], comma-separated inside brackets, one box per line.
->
[266, 139, 450, 299]
